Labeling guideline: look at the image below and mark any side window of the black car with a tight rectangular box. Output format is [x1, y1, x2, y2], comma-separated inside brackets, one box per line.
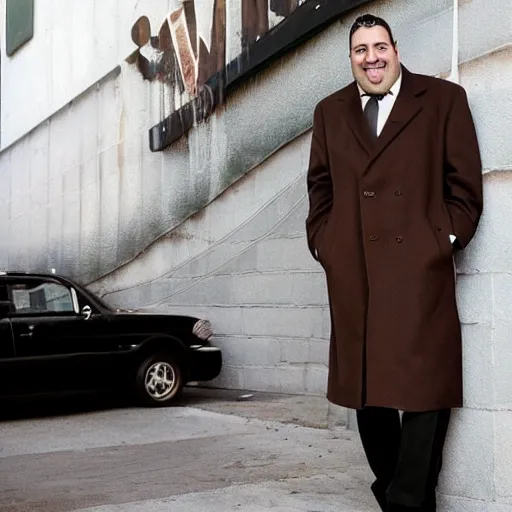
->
[11, 280, 74, 313]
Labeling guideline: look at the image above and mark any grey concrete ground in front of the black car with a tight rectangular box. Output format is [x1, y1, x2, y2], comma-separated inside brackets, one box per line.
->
[0, 388, 378, 512]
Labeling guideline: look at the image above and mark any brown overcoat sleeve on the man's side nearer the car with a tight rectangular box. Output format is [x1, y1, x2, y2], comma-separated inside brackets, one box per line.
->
[306, 104, 333, 260]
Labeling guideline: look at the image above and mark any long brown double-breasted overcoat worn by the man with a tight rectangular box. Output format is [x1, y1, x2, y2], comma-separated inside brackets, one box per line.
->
[306, 67, 482, 411]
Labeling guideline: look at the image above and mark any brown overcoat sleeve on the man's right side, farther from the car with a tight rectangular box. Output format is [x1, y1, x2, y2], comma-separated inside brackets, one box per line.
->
[444, 87, 483, 249]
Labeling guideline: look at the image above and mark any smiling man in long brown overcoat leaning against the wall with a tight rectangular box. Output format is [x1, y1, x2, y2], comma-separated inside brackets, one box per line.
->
[306, 15, 482, 512]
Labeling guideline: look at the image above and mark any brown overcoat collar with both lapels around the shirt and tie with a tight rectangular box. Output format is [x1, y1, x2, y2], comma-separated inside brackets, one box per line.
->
[338, 65, 427, 166]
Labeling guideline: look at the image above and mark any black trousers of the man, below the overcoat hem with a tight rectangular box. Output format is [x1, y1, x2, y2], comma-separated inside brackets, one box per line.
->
[357, 407, 451, 512]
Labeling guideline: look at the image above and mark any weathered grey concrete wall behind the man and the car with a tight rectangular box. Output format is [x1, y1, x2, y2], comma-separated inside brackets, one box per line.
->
[0, 0, 512, 512]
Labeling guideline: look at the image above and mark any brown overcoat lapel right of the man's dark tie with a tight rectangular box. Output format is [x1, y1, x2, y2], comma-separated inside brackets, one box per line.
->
[363, 66, 426, 168]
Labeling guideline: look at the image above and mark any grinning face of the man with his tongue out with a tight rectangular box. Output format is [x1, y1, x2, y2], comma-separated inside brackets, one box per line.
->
[350, 25, 400, 94]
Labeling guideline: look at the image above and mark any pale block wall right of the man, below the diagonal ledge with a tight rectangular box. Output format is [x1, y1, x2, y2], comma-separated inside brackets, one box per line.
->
[434, 46, 512, 512]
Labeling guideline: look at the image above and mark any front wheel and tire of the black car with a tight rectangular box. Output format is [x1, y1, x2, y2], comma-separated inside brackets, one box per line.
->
[136, 353, 183, 407]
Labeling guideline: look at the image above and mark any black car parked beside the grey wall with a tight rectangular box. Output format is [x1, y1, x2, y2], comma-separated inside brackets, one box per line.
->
[0, 272, 222, 405]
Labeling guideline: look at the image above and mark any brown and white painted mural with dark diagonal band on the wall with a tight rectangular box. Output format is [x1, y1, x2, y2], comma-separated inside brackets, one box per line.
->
[128, 0, 367, 151]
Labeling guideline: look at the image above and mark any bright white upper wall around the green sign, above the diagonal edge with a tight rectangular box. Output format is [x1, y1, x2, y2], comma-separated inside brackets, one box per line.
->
[0, 0, 184, 148]
